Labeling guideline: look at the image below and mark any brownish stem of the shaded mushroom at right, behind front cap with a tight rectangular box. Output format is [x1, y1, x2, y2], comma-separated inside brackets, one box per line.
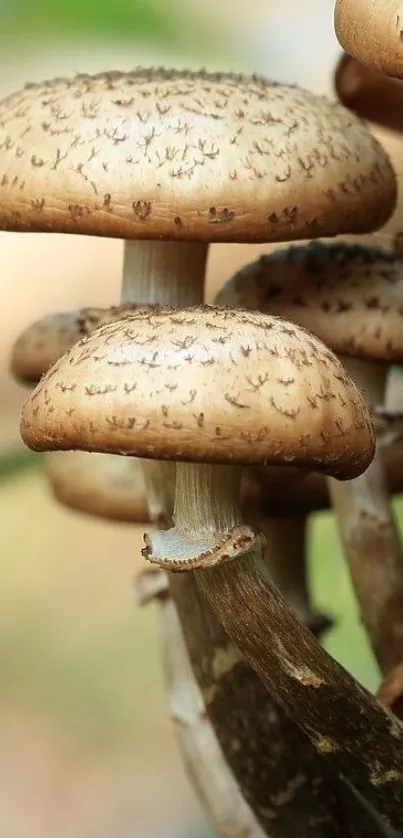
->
[329, 358, 403, 673]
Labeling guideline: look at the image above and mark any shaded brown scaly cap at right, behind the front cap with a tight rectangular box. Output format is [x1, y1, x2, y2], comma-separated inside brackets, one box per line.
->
[216, 242, 403, 363]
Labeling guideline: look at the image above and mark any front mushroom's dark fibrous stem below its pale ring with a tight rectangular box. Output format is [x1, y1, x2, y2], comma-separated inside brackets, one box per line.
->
[195, 548, 403, 834]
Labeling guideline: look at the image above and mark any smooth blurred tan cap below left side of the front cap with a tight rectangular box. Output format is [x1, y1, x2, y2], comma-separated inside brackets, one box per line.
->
[45, 451, 150, 524]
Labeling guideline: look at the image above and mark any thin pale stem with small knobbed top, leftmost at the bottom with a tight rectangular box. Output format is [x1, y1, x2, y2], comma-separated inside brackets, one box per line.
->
[136, 569, 266, 838]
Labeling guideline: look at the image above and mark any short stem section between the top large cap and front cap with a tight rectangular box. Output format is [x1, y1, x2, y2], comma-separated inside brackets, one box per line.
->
[121, 240, 208, 308]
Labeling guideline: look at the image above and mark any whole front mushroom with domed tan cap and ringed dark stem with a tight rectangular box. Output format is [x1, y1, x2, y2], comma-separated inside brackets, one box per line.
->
[21, 306, 403, 827]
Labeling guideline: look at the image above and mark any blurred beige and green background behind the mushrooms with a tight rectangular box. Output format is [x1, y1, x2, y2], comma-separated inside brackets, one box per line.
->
[0, 0, 402, 838]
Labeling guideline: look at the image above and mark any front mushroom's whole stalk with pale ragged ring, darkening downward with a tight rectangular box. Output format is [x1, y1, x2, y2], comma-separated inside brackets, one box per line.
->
[145, 463, 403, 829]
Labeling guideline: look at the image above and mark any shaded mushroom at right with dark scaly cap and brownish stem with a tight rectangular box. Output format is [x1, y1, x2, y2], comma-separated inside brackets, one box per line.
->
[217, 238, 403, 684]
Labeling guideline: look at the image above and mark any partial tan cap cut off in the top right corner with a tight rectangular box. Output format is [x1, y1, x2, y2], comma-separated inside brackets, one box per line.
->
[334, 0, 403, 78]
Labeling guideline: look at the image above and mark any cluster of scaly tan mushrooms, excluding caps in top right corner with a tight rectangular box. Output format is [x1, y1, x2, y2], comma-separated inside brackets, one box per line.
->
[4, 60, 403, 838]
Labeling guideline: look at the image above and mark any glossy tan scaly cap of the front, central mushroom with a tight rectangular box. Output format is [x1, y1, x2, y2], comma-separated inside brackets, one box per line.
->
[21, 306, 374, 478]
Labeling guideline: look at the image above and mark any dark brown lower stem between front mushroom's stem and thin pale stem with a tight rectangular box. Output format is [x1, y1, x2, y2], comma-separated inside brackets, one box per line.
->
[169, 573, 356, 838]
